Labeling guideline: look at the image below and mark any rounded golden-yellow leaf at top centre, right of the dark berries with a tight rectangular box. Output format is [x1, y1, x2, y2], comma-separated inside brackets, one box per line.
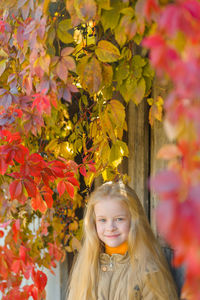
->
[95, 40, 120, 62]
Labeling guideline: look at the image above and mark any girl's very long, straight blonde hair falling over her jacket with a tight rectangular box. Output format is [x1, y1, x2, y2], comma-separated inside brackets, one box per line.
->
[67, 181, 176, 300]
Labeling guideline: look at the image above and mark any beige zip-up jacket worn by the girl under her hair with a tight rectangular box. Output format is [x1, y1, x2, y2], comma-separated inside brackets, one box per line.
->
[98, 253, 178, 300]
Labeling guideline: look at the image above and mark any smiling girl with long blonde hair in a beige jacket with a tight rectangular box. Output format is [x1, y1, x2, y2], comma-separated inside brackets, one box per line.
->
[67, 182, 178, 300]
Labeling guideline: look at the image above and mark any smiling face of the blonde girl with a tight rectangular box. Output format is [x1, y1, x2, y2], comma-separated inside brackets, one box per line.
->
[94, 197, 131, 247]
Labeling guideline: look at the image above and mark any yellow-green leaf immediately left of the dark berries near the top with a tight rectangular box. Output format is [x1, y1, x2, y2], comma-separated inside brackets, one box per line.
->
[57, 19, 74, 44]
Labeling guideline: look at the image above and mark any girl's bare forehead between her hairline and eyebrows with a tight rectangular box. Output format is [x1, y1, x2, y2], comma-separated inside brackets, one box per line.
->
[94, 197, 129, 216]
